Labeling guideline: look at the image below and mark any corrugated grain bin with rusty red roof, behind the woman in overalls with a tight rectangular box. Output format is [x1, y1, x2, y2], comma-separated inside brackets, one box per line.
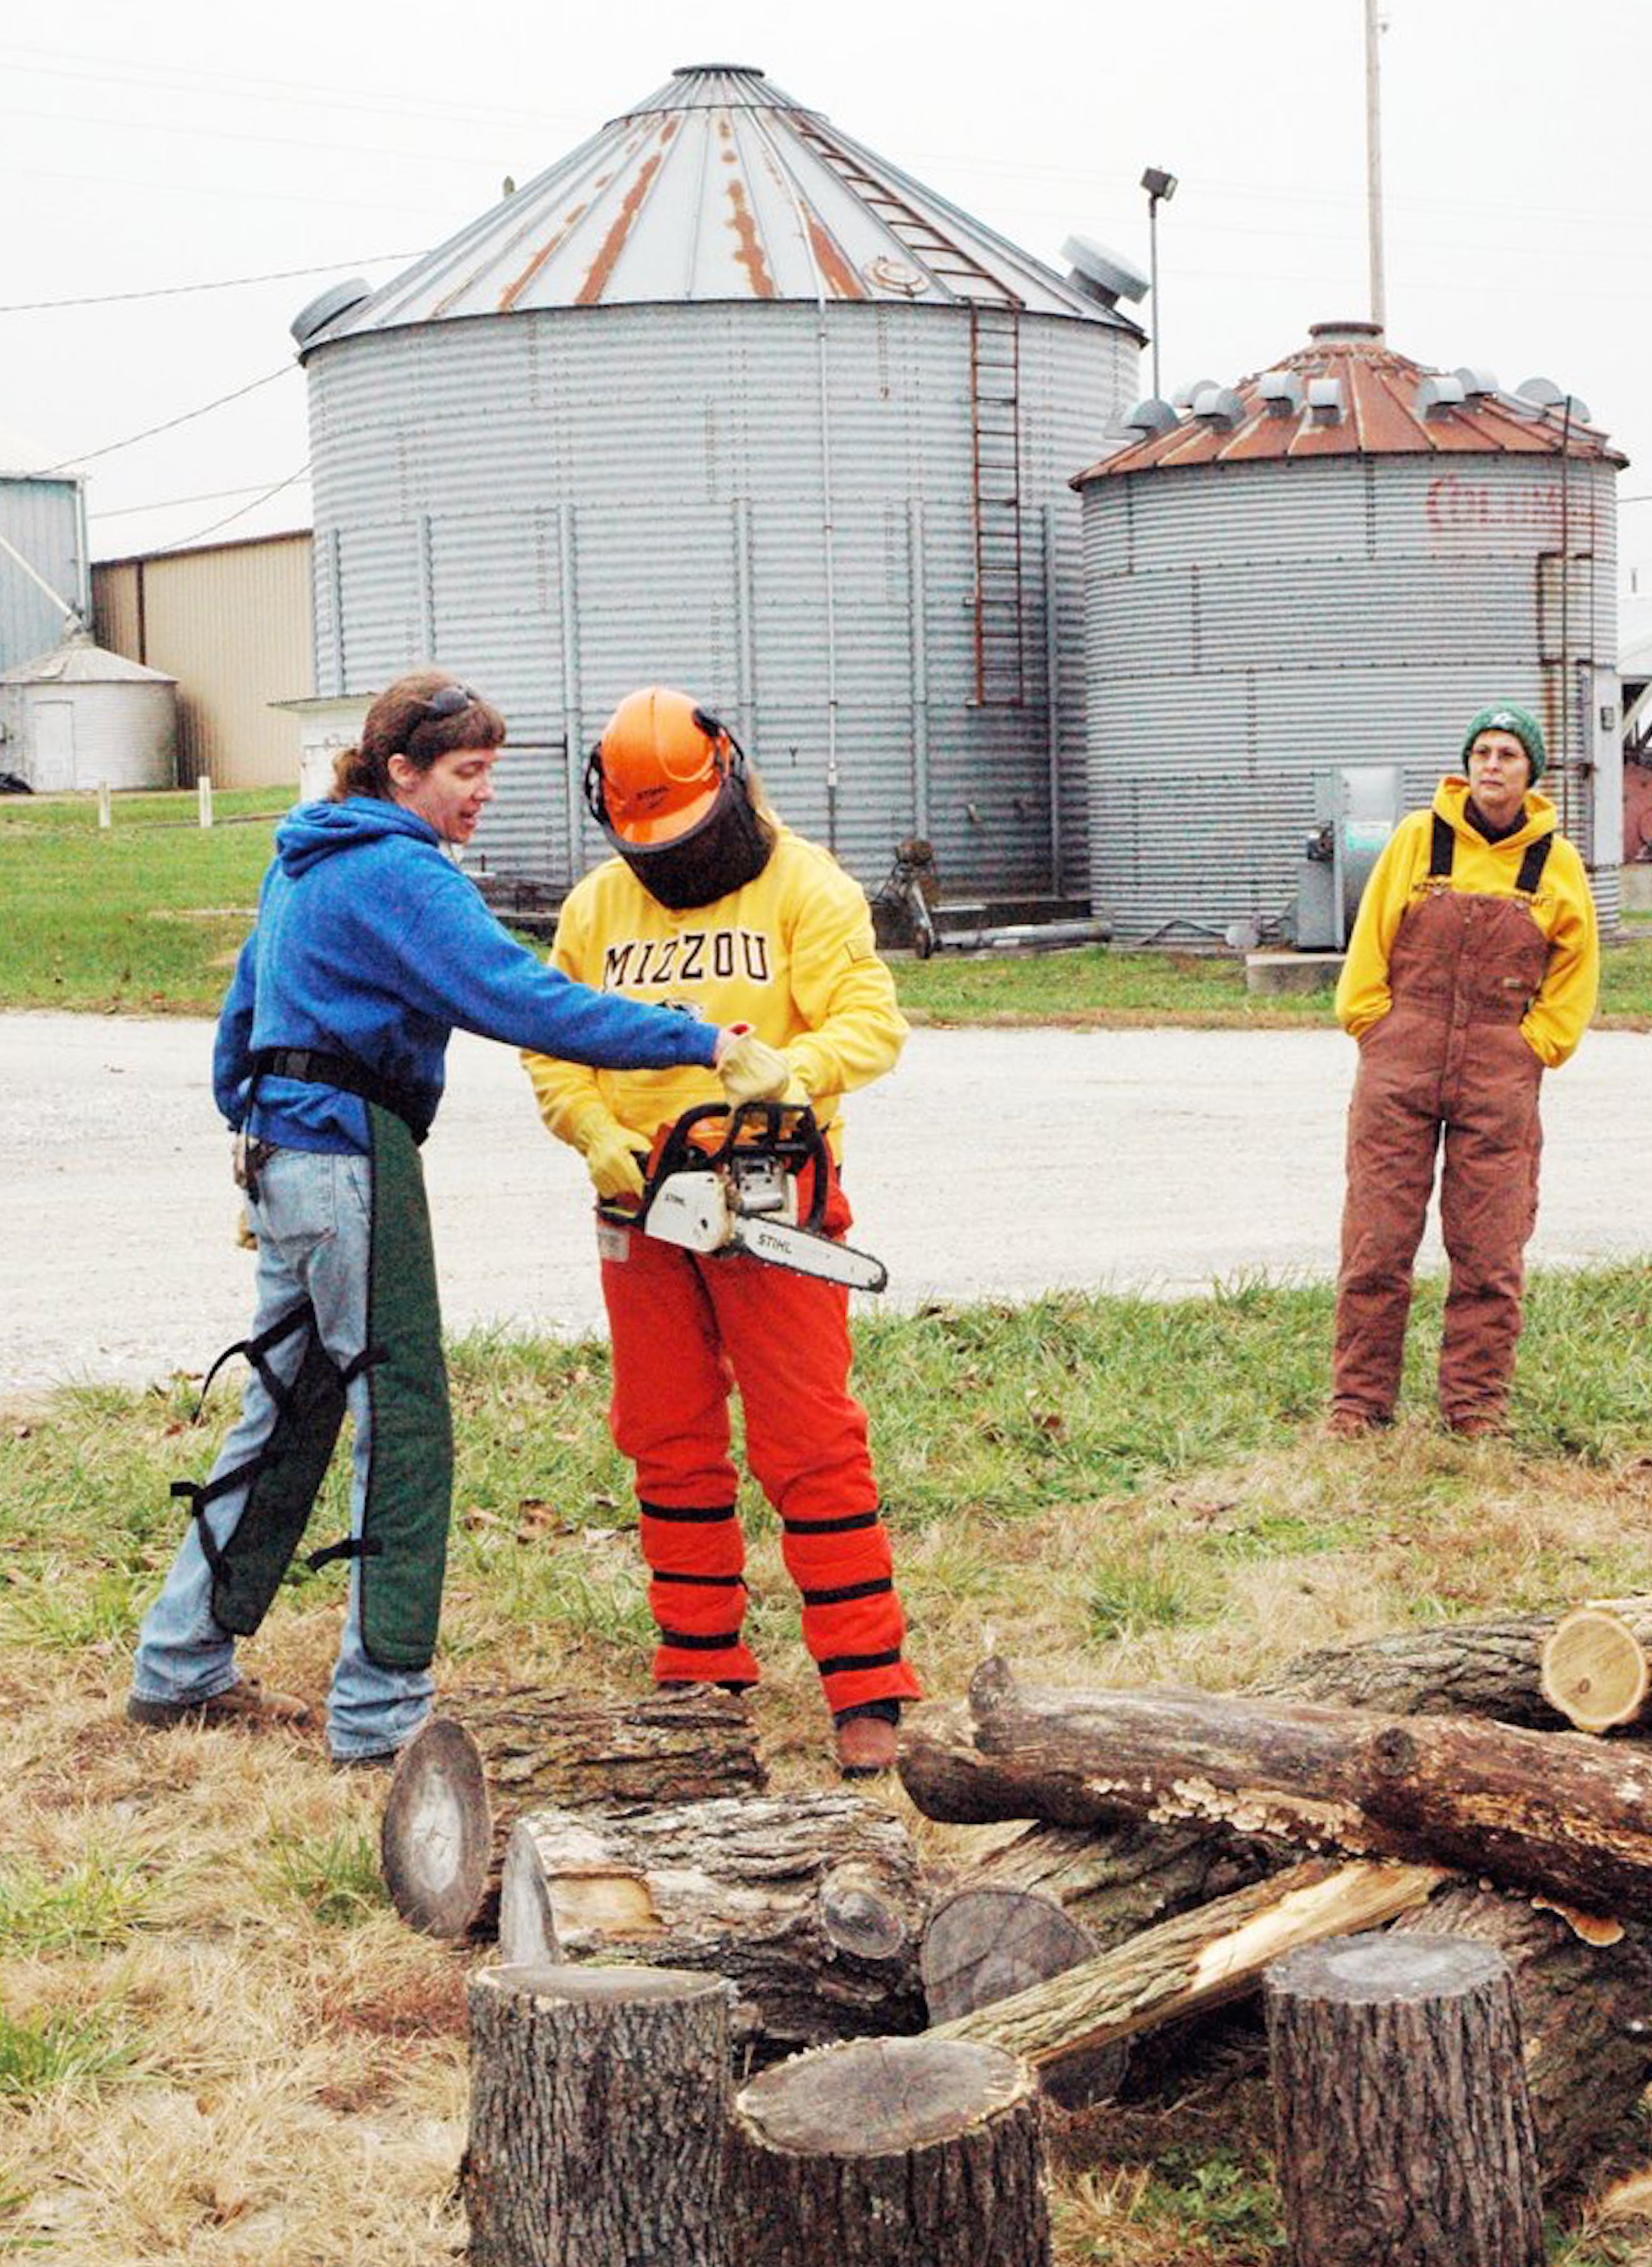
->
[1074, 322, 1625, 948]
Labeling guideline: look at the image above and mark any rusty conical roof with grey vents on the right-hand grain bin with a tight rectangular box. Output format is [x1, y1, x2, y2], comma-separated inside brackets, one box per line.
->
[1072, 322, 1627, 487]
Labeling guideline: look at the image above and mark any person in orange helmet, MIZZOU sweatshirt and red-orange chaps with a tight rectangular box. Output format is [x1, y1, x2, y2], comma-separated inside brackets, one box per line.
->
[523, 687, 918, 1775]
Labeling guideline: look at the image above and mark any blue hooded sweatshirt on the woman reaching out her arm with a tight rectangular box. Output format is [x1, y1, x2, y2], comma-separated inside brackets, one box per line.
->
[213, 795, 716, 1152]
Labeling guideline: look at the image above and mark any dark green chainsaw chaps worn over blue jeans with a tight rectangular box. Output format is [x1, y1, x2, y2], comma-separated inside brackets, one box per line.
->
[203, 1102, 453, 1669]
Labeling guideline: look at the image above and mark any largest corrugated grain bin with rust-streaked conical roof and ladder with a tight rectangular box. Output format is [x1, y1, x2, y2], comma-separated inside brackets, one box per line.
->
[295, 66, 1142, 895]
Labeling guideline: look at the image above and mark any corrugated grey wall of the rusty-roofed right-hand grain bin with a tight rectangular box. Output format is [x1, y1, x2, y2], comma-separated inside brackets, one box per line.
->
[1083, 458, 1616, 943]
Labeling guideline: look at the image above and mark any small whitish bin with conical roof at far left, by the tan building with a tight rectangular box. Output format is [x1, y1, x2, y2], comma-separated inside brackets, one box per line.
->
[0, 635, 177, 795]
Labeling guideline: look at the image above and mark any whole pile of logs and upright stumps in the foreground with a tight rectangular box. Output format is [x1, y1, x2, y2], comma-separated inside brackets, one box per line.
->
[415, 1598, 1652, 2267]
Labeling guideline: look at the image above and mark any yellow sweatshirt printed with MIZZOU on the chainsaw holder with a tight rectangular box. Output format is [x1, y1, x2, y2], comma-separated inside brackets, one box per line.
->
[523, 825, 906, 1156]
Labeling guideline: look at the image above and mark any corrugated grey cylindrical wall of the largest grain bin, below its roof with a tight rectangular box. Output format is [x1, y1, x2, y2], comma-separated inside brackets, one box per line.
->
[310, 304, 1135, 891]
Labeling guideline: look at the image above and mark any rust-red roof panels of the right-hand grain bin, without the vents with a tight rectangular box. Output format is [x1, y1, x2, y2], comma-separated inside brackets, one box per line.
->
[1072, 322, 1625, 487]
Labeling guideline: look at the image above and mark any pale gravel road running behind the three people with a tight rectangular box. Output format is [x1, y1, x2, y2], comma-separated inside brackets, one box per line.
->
[0, 1016, 1652, 1394]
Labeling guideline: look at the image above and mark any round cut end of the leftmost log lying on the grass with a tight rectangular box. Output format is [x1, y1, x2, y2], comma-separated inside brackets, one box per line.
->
[379, 1716, 494, 1941]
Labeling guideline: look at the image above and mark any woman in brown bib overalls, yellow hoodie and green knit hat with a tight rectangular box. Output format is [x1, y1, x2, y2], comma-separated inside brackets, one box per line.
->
[1330, 703, 1600, 1437]
